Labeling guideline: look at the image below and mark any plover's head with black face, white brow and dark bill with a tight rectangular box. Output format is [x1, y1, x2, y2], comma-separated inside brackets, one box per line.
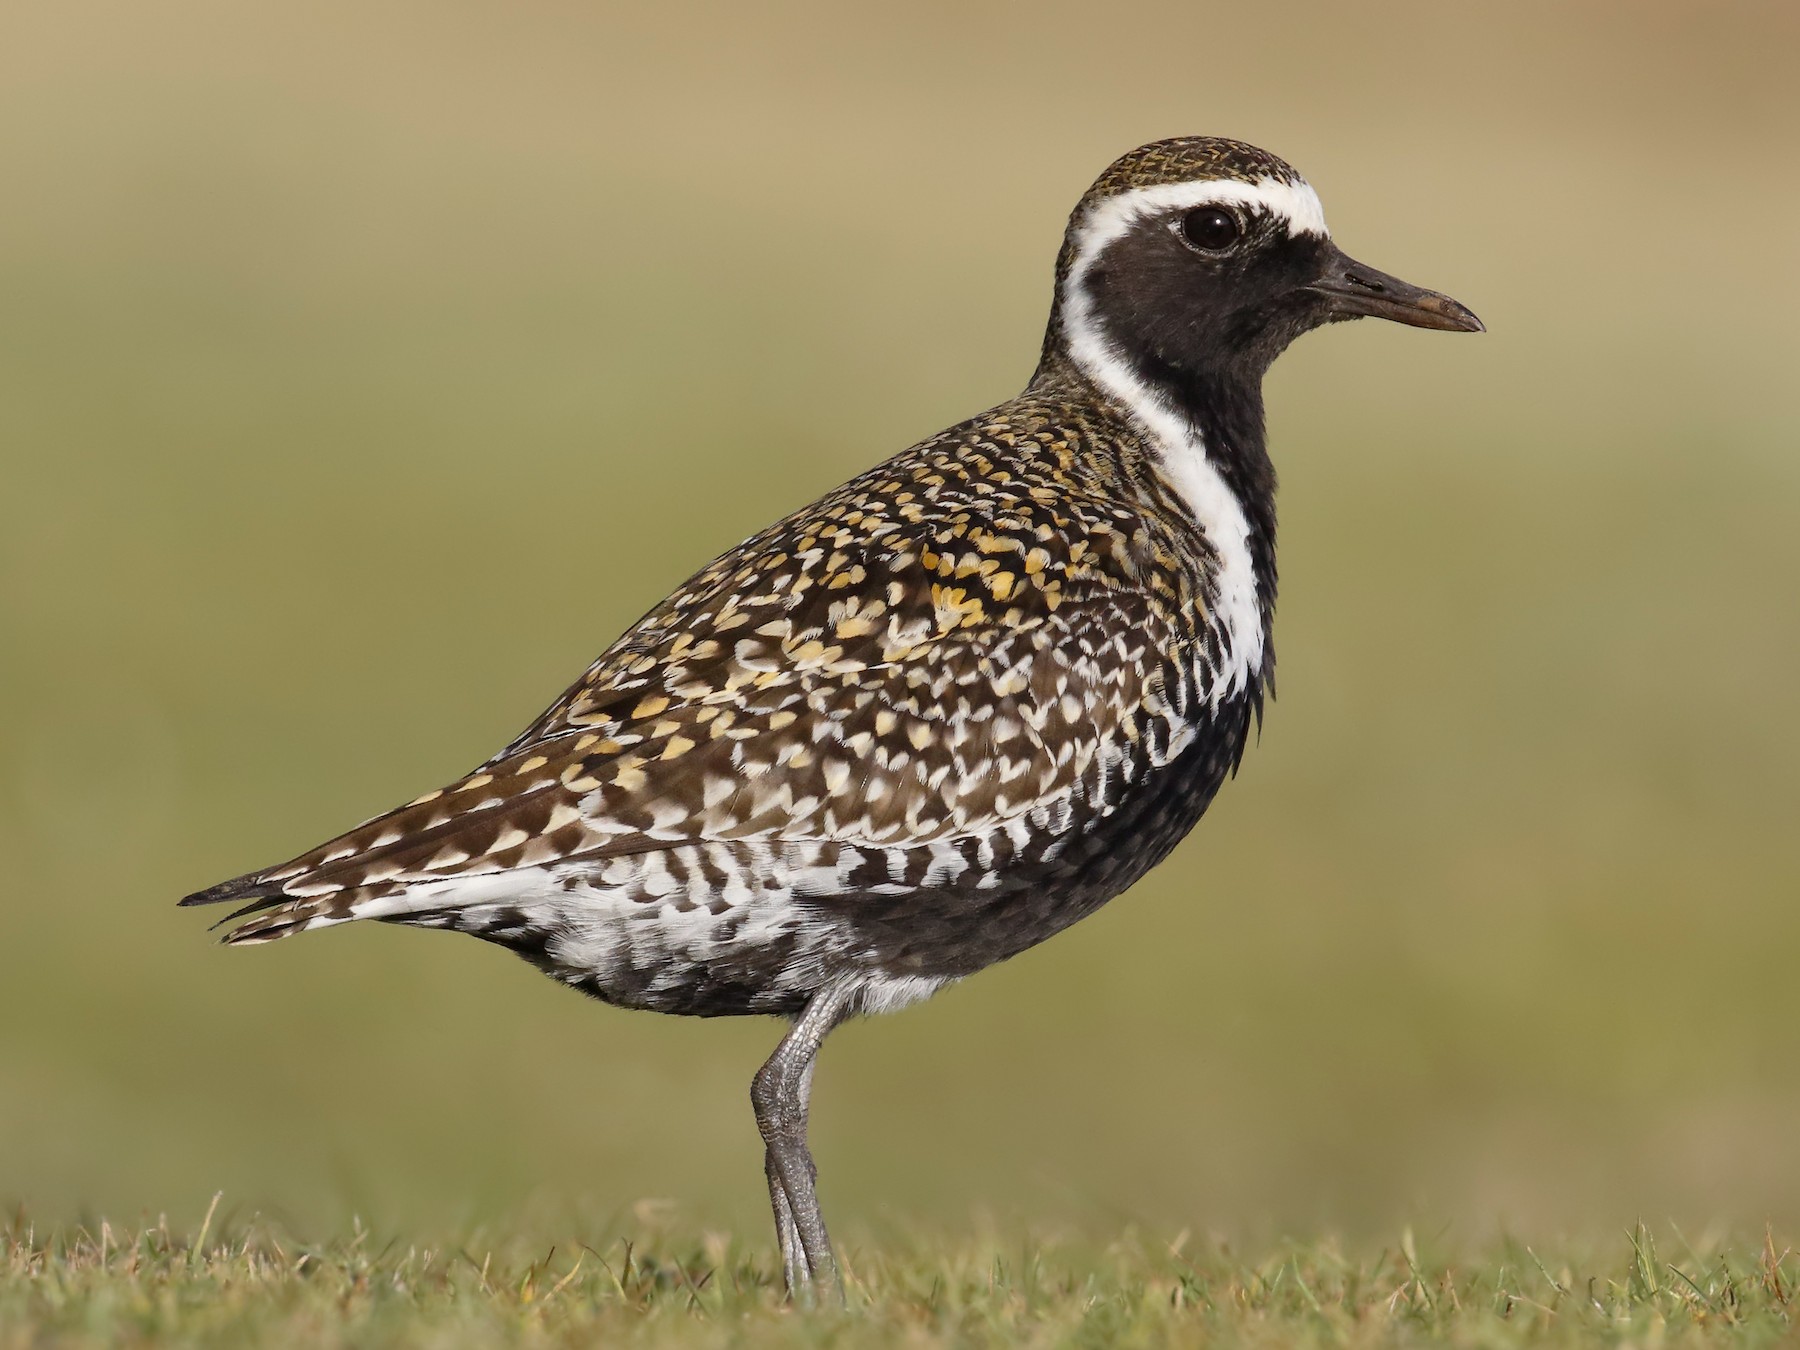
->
[1049, 137, 1481, 394]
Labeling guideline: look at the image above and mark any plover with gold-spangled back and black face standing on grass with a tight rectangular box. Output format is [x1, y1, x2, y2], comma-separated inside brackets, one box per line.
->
[182, 137, 1481, 1291]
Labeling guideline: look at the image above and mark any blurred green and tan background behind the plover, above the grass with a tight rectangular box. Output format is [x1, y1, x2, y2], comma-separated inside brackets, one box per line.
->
[0, 0, 1800, 1238]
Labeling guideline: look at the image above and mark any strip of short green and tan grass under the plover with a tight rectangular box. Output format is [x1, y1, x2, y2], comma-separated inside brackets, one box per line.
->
[0, 1211, 1800, 1350]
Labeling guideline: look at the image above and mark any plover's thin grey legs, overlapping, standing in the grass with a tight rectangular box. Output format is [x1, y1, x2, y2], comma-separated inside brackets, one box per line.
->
[751, 983, 857, 1296]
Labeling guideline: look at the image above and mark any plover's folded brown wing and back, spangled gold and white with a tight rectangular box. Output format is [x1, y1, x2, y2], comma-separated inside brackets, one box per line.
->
[189, 430, 1204, 913]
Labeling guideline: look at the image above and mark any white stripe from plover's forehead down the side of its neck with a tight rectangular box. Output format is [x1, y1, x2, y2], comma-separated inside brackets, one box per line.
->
[1062, 178, 1327, 707]
